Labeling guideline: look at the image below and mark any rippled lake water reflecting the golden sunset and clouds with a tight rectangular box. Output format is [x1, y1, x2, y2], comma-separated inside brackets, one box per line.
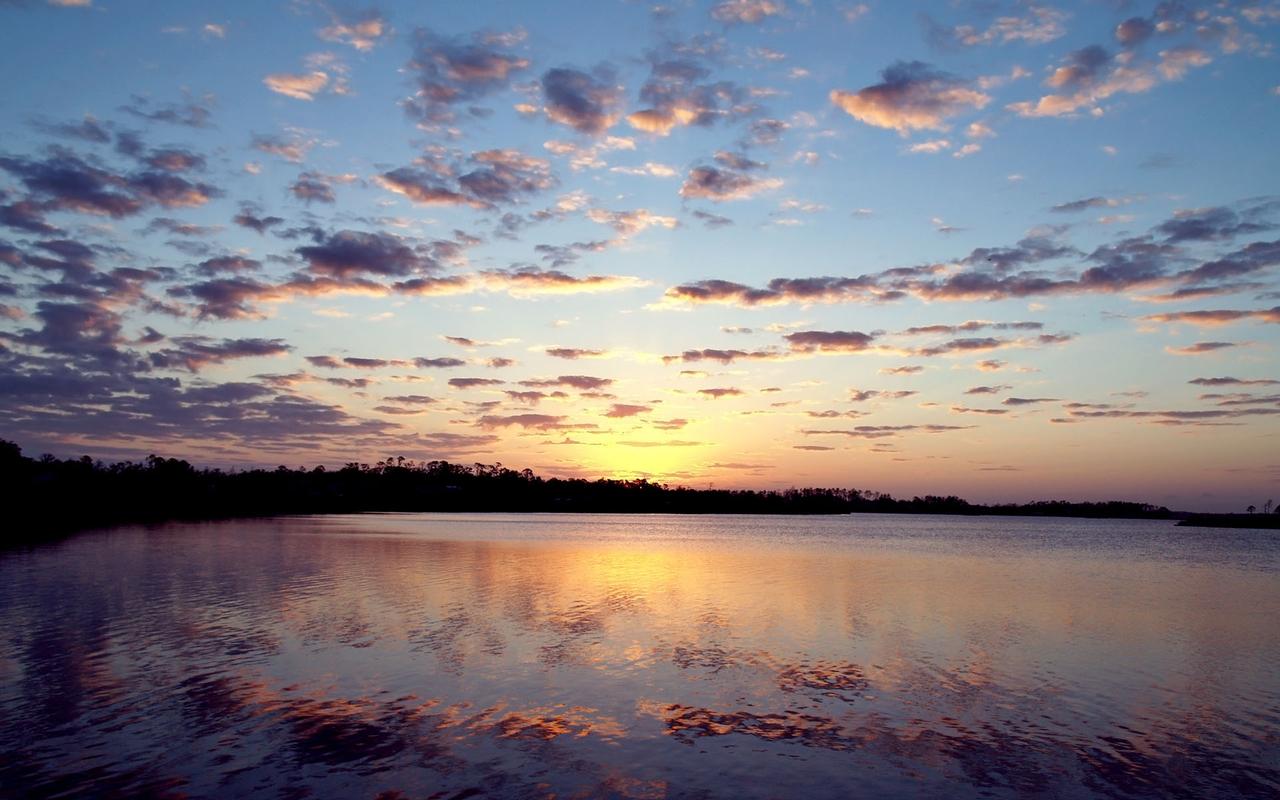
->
[0, 515, 1280, 799]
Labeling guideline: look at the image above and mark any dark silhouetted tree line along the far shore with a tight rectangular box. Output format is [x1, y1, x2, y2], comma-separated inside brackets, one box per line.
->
[0, 440, 1280, 543]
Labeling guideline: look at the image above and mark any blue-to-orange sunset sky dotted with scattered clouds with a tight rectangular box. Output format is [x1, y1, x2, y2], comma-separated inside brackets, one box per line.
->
[0, 0, 1280, 511]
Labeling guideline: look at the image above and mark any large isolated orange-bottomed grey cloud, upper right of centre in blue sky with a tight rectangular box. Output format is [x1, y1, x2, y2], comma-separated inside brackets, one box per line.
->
[831, 61, 991, 134]
